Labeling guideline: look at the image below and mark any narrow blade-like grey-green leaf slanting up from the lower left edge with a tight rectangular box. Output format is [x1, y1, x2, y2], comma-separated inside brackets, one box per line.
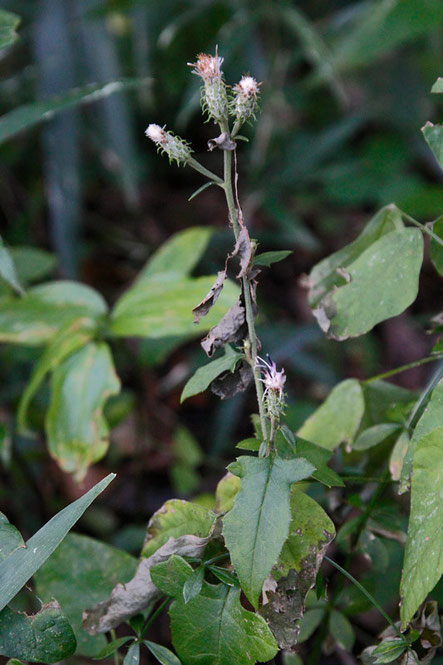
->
[0, 473, 115, 610]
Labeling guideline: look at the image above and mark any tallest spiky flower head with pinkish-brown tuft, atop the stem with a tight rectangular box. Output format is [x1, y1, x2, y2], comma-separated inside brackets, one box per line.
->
[188, 51, 228, 122]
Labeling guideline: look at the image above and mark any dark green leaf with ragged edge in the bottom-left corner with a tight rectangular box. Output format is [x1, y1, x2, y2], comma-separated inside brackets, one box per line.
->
[0, 601, 77, 663]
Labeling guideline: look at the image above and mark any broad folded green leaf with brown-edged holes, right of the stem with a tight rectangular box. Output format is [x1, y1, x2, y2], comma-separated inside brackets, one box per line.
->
[308, 205, 423, 340]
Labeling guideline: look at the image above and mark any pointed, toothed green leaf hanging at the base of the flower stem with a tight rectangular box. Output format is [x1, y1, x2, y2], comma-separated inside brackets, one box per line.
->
[223, 457, 315, 607]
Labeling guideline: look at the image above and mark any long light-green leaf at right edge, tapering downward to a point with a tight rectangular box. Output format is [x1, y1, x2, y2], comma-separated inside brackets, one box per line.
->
[400, 428, 443, 626]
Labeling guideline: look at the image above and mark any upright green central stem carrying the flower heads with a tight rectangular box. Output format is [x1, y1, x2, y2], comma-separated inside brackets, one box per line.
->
[220, 122, 268, 441]
